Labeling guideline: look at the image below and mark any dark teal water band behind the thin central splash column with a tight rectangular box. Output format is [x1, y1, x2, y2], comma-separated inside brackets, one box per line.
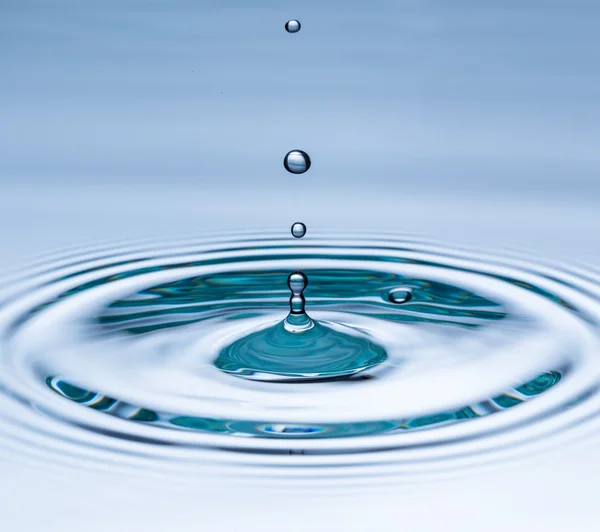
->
[98, 268, 506, 334]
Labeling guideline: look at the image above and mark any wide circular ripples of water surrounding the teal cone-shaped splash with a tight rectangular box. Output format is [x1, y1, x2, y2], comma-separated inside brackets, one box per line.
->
[0, 231, 600, 481]
